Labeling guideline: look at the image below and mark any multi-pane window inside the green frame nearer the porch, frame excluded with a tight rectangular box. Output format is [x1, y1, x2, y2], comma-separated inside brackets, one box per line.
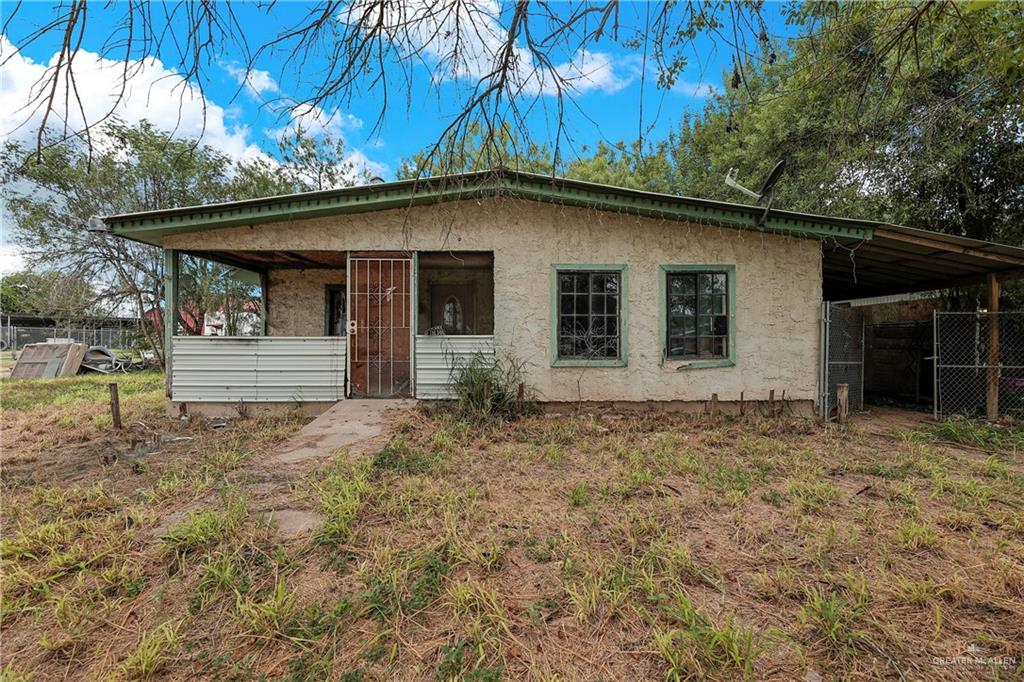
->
[557, 270, 623, 360]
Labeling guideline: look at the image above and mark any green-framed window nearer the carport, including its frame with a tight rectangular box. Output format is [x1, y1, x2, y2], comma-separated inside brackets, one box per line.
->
[658, 265, 736, 368]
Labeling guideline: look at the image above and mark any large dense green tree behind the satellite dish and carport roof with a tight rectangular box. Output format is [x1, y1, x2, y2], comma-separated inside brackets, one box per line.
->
[671, 3, 1024, 244]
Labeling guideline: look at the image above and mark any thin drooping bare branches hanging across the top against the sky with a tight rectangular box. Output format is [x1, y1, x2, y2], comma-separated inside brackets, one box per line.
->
[3, 0, 1007, 175]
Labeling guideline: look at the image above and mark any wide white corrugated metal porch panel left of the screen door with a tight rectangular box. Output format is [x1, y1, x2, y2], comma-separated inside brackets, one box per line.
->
[171, 336, 346, 402]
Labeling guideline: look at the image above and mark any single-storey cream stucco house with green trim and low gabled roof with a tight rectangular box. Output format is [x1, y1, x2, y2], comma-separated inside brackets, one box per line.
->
[102, 169, 1024, 411]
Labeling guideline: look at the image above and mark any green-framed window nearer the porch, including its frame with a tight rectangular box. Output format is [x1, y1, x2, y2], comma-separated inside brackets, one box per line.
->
[551, 264, 629, 367]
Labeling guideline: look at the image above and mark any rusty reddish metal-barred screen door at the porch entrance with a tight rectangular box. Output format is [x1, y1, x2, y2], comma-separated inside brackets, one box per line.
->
[347, 255, 413, 397]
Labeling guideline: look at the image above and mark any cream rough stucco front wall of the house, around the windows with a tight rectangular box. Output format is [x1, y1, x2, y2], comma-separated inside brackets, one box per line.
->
[165, 199, 821, 400]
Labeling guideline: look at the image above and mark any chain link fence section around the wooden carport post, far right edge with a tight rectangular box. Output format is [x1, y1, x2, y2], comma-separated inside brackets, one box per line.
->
[933, 312, 1024, 419]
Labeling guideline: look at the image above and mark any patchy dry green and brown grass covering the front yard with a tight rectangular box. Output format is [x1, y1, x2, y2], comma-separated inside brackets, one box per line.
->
[0, 375, 1024, 680]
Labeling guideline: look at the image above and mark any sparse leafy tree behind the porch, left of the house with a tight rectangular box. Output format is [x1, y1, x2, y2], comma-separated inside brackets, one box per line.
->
[0, 121, 364, 359]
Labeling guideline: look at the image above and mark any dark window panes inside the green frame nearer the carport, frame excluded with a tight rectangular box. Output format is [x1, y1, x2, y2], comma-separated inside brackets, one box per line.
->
[665, 270, 729, 359]
